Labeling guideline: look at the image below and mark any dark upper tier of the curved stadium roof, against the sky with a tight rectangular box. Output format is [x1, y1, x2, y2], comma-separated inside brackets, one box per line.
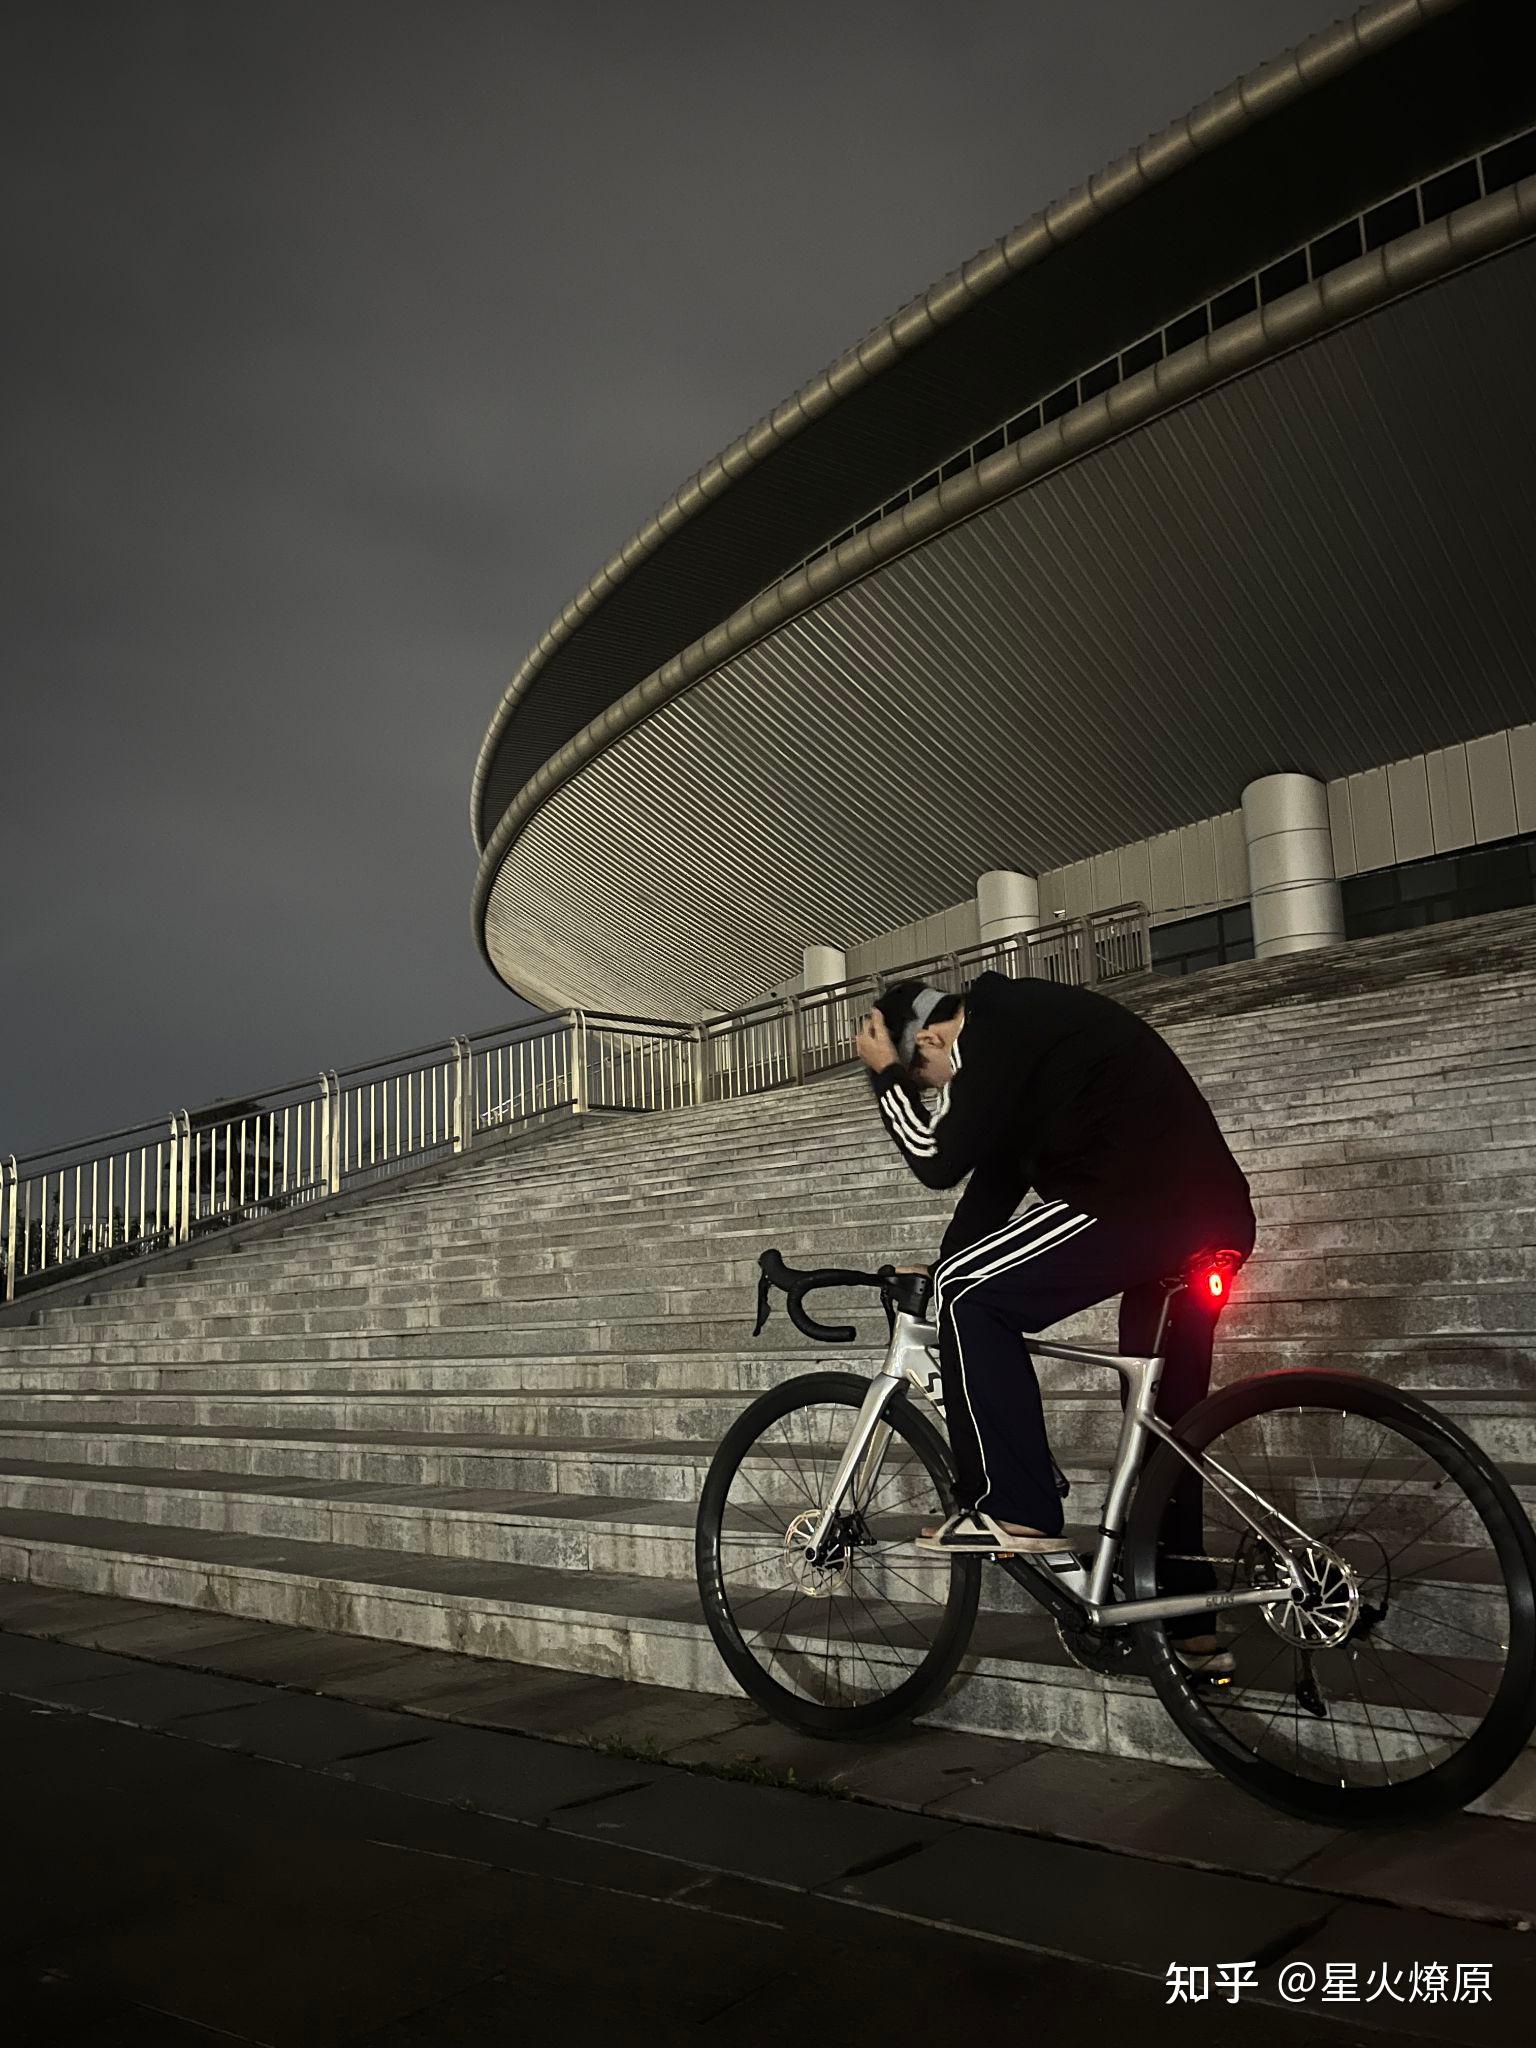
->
[471, 0, 1536, 846]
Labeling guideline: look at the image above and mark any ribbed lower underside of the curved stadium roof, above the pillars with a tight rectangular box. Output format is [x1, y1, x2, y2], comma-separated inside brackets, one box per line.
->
[485, 246, 1536, 1016]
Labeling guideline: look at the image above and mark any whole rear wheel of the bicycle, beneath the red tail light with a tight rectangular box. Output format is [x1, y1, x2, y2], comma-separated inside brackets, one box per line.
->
[1126, 1370, 1536, 1827]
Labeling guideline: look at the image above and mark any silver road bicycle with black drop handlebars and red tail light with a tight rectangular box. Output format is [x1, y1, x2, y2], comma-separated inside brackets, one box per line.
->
[694, 1249, 1536, 1827]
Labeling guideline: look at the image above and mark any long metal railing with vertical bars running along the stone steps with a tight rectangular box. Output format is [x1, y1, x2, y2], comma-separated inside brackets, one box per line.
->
[0, 903, 1151, 1303]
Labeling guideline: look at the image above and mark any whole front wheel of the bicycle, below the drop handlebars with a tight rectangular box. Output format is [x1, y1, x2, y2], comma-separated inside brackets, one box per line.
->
[694, 1372, 981, 1737]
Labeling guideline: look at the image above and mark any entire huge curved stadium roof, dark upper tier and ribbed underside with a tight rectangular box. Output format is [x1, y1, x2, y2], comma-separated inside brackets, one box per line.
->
[471, 0, 1536, 1016]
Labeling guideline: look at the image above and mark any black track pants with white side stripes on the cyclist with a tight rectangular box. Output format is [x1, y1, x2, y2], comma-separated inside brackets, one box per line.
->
[934, 1202, 1253, 1634]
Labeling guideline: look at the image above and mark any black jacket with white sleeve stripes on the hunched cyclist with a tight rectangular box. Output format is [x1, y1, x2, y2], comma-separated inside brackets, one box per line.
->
[870, 973, 1253, 1257]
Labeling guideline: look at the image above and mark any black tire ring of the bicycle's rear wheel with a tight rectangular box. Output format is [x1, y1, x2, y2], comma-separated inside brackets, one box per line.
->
[1124, 1368, 1536, 1827]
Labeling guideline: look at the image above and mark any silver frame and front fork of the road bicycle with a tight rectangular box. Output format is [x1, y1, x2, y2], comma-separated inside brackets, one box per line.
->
[807, 1311, 1307, 1628]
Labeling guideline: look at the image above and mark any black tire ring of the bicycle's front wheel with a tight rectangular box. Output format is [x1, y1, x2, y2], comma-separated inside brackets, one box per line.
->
[694, 1372, 981, 1741]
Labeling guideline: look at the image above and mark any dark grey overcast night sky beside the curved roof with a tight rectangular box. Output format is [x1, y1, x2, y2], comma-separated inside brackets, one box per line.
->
[0, 0, 1346, 1157]
